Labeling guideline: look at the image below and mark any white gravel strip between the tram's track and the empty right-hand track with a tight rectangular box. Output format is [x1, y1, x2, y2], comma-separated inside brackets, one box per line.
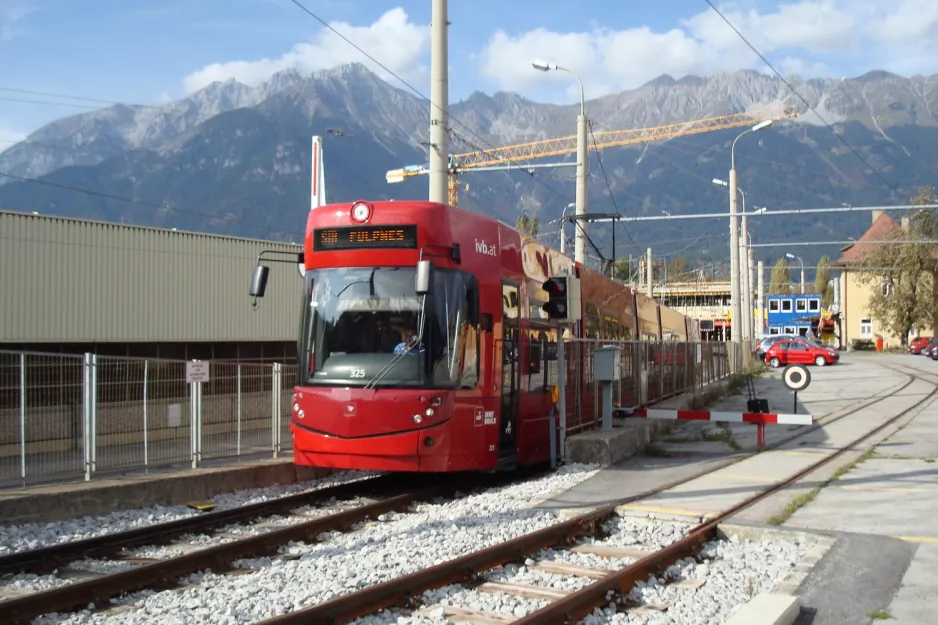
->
[35, 465, 597, 625]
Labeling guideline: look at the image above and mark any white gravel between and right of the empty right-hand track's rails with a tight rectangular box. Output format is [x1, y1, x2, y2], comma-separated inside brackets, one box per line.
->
[353, 517, 807, 625]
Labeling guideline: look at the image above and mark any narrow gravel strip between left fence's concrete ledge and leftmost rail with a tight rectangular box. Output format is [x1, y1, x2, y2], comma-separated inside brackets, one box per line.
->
[0, 471, 377, 556]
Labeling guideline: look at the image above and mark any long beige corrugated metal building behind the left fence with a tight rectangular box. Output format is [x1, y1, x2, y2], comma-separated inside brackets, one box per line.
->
[0, 211, 302, 361]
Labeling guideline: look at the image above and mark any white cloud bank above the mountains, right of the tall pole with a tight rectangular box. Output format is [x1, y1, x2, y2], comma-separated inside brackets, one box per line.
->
[478, 0, 938, 100]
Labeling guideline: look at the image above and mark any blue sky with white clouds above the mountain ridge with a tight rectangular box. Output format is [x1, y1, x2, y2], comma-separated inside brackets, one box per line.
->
[0, 0, 938, 149]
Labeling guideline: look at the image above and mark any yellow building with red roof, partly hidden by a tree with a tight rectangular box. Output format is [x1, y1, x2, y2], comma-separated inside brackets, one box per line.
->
[833, 210, 934, 348]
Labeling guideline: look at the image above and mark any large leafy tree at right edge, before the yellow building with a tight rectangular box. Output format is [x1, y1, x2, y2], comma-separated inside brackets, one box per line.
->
[856, 187, 938, 345]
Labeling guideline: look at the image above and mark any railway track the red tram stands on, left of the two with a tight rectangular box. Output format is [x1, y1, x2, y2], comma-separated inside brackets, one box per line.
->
[0, 468, 540, 624]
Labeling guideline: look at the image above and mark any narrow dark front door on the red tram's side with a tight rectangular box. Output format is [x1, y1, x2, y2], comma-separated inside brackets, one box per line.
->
[498, 281, 521, 456]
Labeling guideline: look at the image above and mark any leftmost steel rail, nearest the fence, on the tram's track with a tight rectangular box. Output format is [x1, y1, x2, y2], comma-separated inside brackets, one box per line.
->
[0, 475, 400, 575]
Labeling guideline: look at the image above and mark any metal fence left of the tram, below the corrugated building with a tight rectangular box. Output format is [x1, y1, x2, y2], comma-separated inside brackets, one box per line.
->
[0, 351, 296, 486]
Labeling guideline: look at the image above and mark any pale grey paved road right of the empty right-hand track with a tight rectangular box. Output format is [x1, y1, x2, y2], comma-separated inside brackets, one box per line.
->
[786, 355, 938, 625]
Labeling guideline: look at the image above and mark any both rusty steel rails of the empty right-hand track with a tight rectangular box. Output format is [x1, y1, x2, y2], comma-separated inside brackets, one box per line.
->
[256, 366, 916, 625]
